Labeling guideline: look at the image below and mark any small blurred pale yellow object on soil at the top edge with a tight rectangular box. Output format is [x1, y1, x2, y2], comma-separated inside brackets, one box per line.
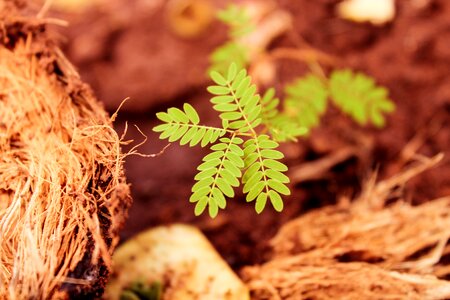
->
[337, 0, 395, 25]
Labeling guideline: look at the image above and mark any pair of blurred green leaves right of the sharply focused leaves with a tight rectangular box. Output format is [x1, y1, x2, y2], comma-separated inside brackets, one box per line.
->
[280, 70, 395, 129]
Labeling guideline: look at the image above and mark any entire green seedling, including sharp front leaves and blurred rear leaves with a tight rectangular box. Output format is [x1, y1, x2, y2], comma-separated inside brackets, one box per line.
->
[157, 5, 395, 218]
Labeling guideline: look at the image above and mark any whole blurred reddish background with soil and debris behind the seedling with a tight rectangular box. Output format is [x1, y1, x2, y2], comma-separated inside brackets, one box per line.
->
[50, 0, 450, 268]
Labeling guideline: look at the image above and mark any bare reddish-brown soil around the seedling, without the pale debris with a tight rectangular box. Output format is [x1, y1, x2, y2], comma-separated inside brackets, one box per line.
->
[56, 0, 450, 269]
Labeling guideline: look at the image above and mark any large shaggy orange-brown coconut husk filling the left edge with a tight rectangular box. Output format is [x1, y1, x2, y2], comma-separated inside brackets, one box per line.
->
[0, 1, 131, 299]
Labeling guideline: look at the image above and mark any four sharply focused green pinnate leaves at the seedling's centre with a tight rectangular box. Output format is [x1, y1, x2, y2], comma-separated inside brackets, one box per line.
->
[153, 64, 290, 217]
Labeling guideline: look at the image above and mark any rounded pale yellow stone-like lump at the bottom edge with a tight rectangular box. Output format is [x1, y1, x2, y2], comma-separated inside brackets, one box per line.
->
[105, 225, 250, 300]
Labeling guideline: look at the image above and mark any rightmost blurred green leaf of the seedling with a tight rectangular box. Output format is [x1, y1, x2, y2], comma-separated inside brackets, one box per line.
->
[330, 70, 395, 127]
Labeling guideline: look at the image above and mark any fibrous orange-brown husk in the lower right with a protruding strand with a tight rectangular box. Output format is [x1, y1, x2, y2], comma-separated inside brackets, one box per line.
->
[243, 155, 450, 299]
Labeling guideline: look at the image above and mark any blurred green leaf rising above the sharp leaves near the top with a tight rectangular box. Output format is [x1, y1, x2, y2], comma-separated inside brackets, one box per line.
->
[209, 4, 254, 73]
